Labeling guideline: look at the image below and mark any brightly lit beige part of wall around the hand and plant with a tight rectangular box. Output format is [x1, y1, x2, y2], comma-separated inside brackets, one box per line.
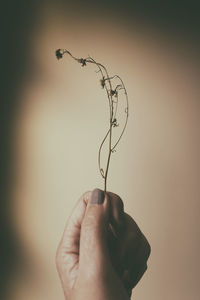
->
[13, 4, 200, 300]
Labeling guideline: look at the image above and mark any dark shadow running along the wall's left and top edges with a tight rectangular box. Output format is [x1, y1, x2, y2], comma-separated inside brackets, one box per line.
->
[0, 0, 200, 299]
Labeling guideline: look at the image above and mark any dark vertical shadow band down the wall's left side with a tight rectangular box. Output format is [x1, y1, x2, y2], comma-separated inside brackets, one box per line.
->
[0, 0, 37, 299]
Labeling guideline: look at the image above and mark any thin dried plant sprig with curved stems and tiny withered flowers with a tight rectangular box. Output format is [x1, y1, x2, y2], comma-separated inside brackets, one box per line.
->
[56, 49, 129, 192]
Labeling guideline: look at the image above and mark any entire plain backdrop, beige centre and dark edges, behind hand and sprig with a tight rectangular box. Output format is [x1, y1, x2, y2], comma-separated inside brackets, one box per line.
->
[1, 1, 200, 300]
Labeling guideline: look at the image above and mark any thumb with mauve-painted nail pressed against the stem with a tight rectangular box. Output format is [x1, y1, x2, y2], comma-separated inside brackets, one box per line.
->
[79, 189, 110, 273]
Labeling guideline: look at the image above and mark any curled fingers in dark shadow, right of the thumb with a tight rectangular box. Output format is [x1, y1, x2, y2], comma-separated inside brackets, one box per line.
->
[97, 192, 151, 286]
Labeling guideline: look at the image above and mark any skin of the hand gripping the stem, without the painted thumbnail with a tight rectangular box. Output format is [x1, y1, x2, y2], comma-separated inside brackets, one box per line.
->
[56, 189, 151, 300]
